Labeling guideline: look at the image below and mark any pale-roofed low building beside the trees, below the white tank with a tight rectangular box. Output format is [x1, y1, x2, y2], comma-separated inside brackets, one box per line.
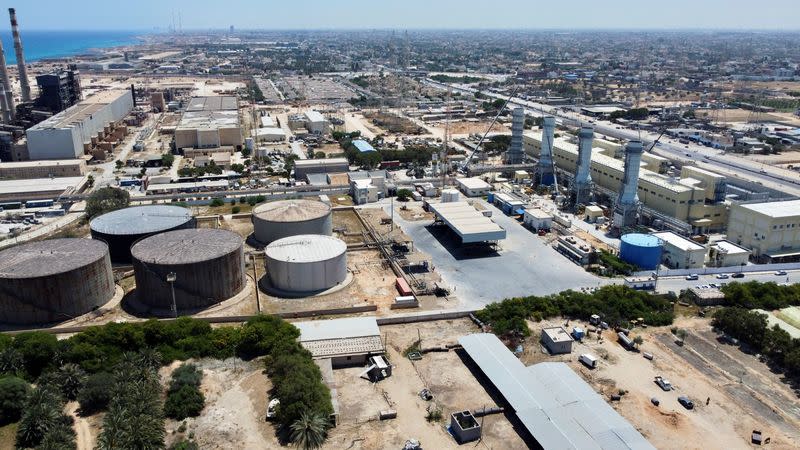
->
[292, 317, 385, 358]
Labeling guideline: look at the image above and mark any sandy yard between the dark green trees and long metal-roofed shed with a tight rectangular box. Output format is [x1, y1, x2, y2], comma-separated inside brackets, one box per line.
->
[323, 320, 527, 450]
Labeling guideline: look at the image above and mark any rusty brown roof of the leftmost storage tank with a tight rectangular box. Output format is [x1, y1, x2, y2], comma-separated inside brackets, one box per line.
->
[0, 238, 108, 278]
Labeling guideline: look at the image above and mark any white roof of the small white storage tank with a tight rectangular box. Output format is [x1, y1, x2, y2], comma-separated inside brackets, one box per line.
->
[266, 234, 347, 263]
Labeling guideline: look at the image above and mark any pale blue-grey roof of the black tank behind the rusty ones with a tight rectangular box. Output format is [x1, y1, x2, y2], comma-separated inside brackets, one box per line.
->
[89, 205, 192, 235]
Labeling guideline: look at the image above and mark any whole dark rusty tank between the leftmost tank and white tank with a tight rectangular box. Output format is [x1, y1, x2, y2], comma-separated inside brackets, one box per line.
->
[131, 228, 245, 310]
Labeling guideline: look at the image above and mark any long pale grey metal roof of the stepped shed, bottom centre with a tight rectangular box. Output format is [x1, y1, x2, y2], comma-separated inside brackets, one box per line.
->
[458, 333, 655, 450]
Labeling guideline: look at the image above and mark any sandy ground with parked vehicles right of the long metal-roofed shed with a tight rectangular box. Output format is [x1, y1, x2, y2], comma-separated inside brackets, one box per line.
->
[522, 319, 798, 449]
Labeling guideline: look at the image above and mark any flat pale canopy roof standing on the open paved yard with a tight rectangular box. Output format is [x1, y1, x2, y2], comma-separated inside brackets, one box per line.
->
[429, 202, 506, 244]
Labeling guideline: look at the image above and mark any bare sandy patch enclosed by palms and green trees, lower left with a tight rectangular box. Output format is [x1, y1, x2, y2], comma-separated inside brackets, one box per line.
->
[162, 358, 280, 449]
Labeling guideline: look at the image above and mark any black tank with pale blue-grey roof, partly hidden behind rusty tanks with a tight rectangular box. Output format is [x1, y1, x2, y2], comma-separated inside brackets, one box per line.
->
[89, 205, 197, 264]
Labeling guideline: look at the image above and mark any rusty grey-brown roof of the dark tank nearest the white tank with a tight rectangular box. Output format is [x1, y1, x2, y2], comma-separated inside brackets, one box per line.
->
[131, 228, 244, 264]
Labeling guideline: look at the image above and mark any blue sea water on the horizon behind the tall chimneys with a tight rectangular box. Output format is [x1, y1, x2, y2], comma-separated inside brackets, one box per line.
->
[0, 29, 144, 65]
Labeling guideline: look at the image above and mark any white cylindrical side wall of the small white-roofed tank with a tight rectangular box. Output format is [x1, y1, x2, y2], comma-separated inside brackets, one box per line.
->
[267, 252, 347, 292]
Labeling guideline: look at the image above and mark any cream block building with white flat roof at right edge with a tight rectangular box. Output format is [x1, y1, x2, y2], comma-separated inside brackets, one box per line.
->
[728, 200, 800, 263]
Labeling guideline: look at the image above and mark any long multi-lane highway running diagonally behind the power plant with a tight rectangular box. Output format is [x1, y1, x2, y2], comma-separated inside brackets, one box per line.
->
[425, 79, 800, 197]
